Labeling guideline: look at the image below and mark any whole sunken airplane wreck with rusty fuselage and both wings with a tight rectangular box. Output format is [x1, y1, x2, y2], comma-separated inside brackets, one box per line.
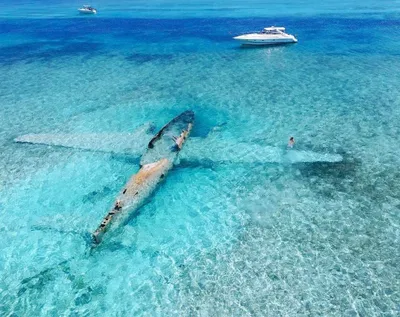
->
[14, 110, 343, 246]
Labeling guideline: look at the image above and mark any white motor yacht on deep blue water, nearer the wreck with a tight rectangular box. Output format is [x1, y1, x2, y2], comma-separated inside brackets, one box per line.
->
[233, 26, 297, 45]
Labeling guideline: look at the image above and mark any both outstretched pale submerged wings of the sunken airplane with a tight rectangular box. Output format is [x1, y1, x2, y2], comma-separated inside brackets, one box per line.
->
[15, 128, 343, 165]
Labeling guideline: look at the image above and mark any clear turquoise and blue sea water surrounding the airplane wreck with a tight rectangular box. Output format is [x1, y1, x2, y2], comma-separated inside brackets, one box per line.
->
[0, 1, 400, 316]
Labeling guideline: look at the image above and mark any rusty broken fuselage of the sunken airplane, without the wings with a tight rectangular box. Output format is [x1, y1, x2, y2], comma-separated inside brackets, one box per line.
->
[93, 111, 194, 245]
